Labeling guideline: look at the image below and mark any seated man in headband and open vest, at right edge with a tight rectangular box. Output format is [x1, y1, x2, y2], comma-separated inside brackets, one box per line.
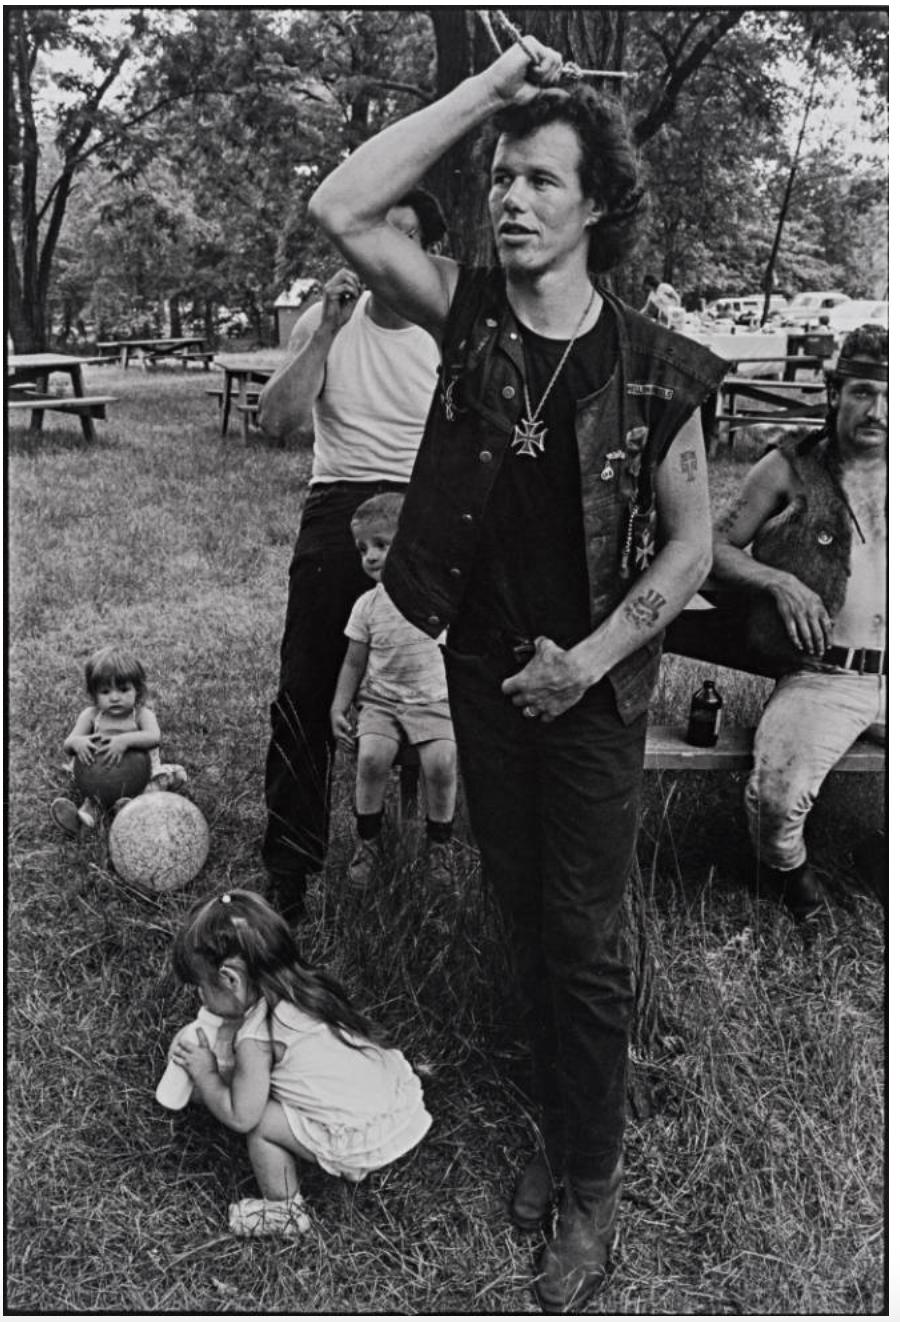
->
[715, 325, 888, 921]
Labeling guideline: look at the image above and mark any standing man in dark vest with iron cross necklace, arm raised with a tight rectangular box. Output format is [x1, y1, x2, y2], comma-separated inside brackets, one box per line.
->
[311, 37, 726, 1311]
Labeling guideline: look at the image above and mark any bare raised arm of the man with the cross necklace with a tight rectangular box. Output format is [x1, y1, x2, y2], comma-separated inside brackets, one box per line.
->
[309, 37, 562, 342]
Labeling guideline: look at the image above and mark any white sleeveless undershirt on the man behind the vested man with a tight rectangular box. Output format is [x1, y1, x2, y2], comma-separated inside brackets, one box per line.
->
[312, 293, 440, 483]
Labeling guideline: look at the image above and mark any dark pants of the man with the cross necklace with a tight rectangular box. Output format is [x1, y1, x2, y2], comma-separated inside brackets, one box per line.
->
[438, 649, 646, 1178]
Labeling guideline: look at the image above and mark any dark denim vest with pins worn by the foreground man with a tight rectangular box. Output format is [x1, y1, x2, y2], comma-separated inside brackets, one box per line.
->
[383, 270, 728, 722]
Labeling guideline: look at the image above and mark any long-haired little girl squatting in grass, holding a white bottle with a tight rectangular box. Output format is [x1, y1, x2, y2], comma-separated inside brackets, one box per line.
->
[170, 891, 431, 1239]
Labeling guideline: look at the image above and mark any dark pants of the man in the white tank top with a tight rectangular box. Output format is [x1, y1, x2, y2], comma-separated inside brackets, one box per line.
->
[263, 481, 406, 880]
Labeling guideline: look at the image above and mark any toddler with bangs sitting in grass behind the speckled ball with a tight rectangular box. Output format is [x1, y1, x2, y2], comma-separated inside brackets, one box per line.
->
[50, 646, 188, 836]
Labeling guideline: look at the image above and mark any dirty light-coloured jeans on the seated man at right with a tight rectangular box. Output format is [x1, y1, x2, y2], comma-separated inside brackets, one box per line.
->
[744, 670, 887, 871]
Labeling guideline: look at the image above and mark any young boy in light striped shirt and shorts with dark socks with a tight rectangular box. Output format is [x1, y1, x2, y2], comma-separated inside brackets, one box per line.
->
[330, 492, 456, 887]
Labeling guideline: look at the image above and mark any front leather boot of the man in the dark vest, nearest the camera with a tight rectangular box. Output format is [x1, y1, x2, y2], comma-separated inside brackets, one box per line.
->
[534, 1157, 622, 1313]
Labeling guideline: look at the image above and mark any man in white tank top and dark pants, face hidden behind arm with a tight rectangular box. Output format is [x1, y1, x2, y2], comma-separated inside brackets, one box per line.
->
[259, 193, 445, 920]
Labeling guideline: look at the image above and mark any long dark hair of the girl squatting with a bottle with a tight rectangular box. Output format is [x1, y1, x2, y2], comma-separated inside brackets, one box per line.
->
[172, 890, 383, 1046]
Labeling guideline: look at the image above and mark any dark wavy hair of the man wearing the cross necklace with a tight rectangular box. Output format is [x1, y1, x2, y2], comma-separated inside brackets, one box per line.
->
[485, 83, 646, 274]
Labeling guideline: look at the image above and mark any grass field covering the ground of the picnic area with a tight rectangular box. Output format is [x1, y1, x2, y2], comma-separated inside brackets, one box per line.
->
[5, 368, 884, 1315]
